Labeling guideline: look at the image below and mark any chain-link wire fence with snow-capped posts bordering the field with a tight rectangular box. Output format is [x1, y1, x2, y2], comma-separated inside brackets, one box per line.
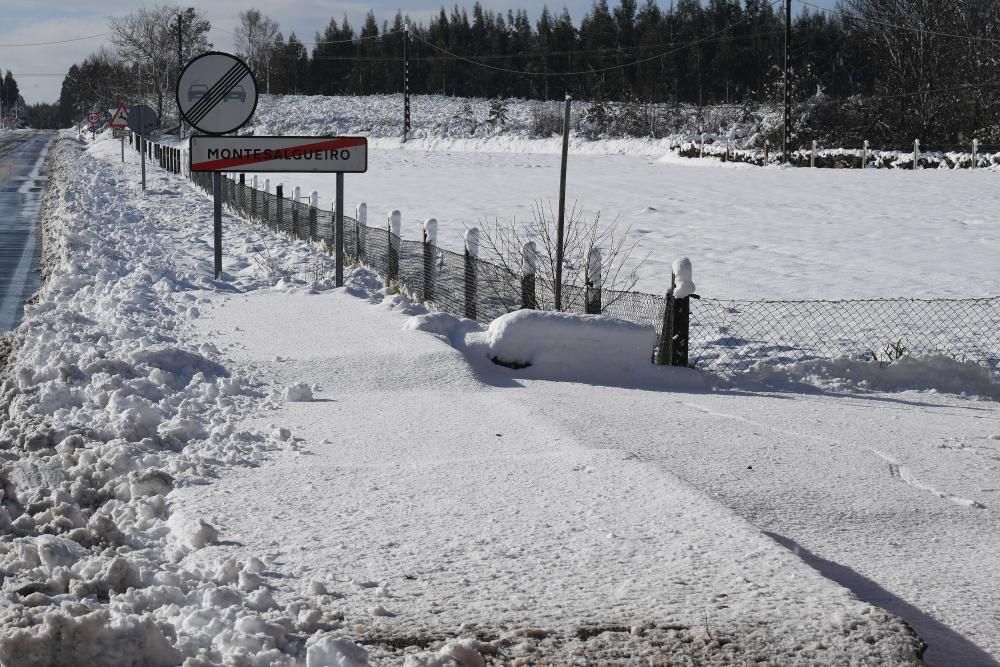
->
[158, 136, 1000, 374]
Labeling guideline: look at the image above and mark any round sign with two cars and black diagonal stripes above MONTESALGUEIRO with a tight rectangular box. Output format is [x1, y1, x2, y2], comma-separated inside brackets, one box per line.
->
[177, 51, 257, 134]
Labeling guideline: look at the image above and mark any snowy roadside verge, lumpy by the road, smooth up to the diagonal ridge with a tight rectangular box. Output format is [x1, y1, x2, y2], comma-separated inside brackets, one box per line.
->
[0, 134, 936, 666]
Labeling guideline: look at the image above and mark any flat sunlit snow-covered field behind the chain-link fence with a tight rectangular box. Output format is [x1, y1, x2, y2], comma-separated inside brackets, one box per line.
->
[240, 97, 1000, 299]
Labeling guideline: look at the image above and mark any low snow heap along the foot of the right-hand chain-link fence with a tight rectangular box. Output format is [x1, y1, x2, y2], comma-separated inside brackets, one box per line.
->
[746, 355, 1000, 400]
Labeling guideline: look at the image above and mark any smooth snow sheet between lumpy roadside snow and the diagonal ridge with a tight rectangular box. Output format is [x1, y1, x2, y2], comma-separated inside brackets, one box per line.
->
[172, 290, 928, 664]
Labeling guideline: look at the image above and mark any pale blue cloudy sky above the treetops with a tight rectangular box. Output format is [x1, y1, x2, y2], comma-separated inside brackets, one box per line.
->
[0, 0, 836, 104]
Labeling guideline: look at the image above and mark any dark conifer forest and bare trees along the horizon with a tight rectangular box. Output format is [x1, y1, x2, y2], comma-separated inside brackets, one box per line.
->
[45, 0, 1000, 143]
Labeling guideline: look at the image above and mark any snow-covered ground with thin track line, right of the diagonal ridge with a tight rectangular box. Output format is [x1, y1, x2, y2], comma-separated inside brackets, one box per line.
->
[514, 381, 1000, 665]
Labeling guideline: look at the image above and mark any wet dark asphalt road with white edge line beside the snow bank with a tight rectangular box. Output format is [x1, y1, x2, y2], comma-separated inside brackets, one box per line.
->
[0, 132, 54, 333]
